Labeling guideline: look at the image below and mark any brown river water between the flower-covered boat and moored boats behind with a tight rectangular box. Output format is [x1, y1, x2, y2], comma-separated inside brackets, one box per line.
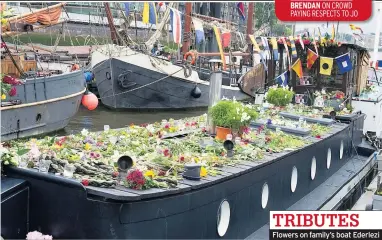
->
[60, 104, 207, 135]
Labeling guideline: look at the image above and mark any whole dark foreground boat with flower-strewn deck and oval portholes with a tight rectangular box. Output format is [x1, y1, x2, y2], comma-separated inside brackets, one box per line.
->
[2, 97, 364, 239]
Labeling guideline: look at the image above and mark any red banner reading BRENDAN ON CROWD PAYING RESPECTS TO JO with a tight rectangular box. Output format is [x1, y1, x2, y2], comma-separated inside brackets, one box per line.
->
[275, 0, 372, 22]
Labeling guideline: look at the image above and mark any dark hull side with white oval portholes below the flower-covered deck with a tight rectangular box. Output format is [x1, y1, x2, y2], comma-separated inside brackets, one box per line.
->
[2, 115, 364, 239]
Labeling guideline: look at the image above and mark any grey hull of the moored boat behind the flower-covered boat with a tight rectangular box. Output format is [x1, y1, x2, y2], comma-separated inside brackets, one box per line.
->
[93, 58, 249, 109]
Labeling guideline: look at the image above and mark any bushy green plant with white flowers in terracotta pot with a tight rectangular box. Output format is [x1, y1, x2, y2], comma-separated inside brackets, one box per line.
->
[210, 100, 258, 140]
